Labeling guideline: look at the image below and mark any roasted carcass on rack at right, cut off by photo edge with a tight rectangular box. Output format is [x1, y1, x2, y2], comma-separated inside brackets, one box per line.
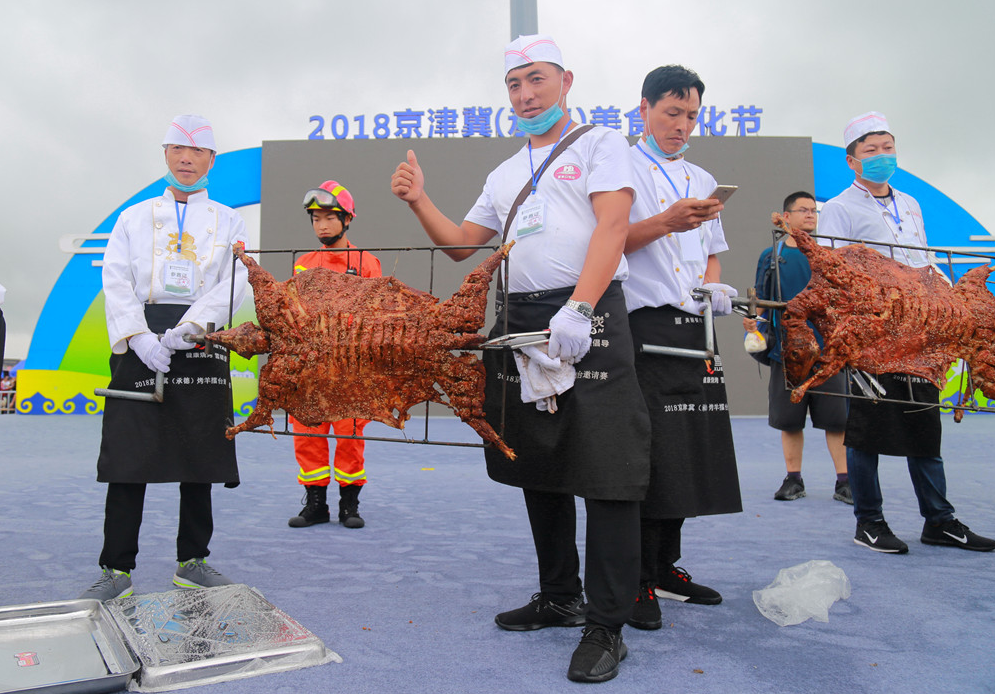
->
[773, 214, 995, 402]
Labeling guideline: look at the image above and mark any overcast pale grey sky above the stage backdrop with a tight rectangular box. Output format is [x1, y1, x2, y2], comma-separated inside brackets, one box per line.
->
[0, 0, 995, 358]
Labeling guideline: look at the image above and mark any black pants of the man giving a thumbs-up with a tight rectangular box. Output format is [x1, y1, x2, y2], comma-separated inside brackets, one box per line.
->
[523, 489, 639, 629]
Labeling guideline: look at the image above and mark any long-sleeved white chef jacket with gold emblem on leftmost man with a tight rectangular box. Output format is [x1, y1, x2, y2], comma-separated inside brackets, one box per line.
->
[103, 188, 248, 354]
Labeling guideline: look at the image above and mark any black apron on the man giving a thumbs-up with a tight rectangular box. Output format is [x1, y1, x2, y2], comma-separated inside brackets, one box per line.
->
[484, 282, 650, 501]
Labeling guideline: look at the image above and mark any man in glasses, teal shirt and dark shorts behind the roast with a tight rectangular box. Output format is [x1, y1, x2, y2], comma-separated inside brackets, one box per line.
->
[743, 191, 853, 504]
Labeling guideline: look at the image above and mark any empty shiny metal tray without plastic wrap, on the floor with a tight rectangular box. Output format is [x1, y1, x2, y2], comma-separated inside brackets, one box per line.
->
[0, 600, 139, 694]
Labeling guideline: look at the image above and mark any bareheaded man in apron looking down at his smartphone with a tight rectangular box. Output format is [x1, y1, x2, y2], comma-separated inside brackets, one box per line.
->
[622, 65, 743, 629]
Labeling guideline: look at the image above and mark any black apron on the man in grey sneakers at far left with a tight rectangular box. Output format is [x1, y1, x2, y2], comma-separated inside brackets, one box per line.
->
[97, 304, 238, 487]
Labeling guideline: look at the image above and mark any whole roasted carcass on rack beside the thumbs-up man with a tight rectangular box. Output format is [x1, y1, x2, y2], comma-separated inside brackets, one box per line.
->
[207, 244, 515, 459]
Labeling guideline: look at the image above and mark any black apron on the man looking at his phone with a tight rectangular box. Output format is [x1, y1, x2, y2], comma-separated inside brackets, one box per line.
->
[629, 306, 743, 518]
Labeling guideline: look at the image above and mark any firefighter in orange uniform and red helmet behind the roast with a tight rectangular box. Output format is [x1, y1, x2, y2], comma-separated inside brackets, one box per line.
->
[288, 181, 381, 528]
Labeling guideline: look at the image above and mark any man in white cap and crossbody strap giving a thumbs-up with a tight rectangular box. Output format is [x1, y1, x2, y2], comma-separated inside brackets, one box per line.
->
[391, 35, 649, 682]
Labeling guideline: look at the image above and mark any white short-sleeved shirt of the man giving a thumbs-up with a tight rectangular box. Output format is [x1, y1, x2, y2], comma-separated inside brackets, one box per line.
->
[466, 126, 635, 293]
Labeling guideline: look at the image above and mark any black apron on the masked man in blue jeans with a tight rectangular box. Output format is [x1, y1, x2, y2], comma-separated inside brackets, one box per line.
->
[843, 374, 942, 458]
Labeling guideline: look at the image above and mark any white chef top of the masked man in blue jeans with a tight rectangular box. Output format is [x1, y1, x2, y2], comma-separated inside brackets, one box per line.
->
[819, 181, 929, 267]
